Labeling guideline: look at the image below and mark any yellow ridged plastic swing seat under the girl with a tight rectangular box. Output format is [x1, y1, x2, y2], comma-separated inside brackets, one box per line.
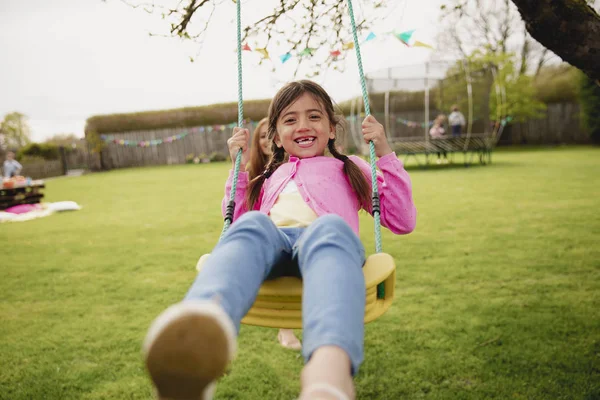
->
[196, 253, 396, 329]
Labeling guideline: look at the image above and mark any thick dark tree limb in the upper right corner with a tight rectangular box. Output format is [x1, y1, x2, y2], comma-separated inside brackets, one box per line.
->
[512, 0, 600, 84]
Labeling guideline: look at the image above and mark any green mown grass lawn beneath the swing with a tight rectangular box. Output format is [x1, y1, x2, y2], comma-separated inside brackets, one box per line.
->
[0, 148, 600, 400]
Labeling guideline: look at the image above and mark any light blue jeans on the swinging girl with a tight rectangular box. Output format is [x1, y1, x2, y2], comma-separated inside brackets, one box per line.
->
[185, 211, 366, 374]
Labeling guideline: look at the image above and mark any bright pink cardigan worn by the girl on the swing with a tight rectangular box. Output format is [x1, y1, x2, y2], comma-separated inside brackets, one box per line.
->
[222, 153, 417, 235]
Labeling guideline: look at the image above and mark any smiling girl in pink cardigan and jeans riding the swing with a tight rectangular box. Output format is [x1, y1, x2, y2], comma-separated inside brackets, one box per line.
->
[143, 80, 416, 400]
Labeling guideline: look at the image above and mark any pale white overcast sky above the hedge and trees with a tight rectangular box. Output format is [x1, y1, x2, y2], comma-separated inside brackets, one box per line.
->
[0, 0, 441, 141]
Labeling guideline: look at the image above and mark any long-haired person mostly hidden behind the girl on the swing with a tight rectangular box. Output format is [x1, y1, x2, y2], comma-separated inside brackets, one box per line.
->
[247, 118, 302, 350]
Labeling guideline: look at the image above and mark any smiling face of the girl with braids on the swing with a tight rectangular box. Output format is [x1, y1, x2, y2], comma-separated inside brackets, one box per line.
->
[275, 93, 335, 158]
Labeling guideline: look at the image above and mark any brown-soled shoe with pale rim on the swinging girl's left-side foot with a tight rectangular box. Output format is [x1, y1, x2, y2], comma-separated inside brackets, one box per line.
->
[143, 301, 236, 400]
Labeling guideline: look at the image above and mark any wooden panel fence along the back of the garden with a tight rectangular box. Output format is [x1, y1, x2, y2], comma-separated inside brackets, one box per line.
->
[88, 103, 589, 170]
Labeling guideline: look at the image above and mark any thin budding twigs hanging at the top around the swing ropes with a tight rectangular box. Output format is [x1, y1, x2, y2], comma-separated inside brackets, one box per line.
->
[120, 0, 387, 74]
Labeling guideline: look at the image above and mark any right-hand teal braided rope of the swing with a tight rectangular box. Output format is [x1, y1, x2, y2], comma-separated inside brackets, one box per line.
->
[348, 0, 385, 298]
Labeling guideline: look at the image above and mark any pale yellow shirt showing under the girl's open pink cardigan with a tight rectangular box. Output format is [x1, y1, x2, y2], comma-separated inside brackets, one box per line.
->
[269, 179, 318, 228]
